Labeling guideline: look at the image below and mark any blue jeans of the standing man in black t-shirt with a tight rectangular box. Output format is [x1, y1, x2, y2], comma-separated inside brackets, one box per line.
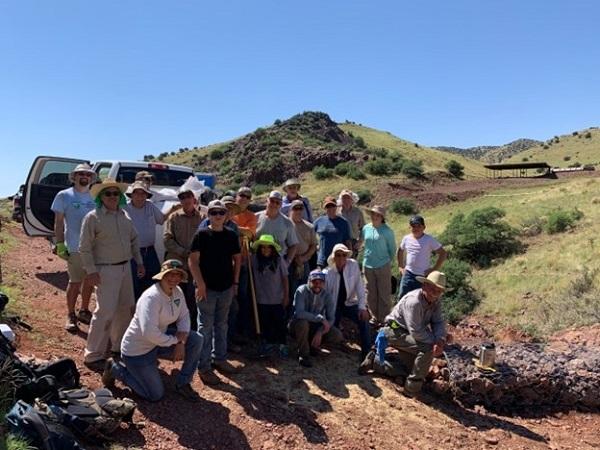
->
[198, 288, 233, 372]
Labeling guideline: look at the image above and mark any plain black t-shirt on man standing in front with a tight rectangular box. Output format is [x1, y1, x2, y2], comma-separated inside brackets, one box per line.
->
[191, 228, 240, 292]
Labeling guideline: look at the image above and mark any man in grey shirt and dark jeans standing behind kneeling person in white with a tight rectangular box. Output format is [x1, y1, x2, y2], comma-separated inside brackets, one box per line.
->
[123, 181, 166, 301]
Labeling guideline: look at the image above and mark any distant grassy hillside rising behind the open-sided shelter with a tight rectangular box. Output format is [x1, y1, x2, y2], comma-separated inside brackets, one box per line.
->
[503, 128, 600, 167]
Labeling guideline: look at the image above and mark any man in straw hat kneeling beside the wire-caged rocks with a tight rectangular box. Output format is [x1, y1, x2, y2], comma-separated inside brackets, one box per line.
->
[361, 270, 449, 397]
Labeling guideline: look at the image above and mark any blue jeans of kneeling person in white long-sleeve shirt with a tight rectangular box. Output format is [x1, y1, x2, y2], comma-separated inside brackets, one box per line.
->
[112, 331, 203, 402]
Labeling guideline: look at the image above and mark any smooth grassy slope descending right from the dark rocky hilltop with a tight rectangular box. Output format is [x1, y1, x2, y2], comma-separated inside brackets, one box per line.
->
[340, 124, 485, 178]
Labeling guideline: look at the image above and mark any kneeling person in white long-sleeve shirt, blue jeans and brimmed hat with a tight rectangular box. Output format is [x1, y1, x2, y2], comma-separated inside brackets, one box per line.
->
[102, 259, 203, 402]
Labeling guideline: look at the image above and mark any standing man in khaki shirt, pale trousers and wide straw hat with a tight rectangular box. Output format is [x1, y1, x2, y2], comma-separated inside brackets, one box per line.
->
[79, 179, 145, 365]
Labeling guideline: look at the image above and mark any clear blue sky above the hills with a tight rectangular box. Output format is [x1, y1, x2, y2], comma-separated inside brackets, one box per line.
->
[0, 0, 600, 196]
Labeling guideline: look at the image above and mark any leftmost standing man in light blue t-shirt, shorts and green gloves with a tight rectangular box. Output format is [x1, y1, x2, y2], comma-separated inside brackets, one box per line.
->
[51, 164, 96, 332]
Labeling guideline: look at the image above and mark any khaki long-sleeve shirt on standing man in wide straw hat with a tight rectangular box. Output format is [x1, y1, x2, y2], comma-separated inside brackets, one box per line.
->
[79, 207, 143, 274]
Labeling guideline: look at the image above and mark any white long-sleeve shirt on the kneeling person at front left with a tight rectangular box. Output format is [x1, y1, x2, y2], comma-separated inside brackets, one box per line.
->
[121, 283, 190, 356]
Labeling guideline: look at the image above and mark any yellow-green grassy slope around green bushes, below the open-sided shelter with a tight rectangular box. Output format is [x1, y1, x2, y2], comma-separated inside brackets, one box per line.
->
[392, 178, 600, 336]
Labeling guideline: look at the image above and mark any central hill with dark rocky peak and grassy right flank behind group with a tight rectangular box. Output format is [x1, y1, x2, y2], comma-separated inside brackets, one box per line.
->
[157, 112, 484, 191]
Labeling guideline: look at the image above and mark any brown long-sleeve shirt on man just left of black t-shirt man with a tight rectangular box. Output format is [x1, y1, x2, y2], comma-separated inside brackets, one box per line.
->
[163, 209, 205, 268]
